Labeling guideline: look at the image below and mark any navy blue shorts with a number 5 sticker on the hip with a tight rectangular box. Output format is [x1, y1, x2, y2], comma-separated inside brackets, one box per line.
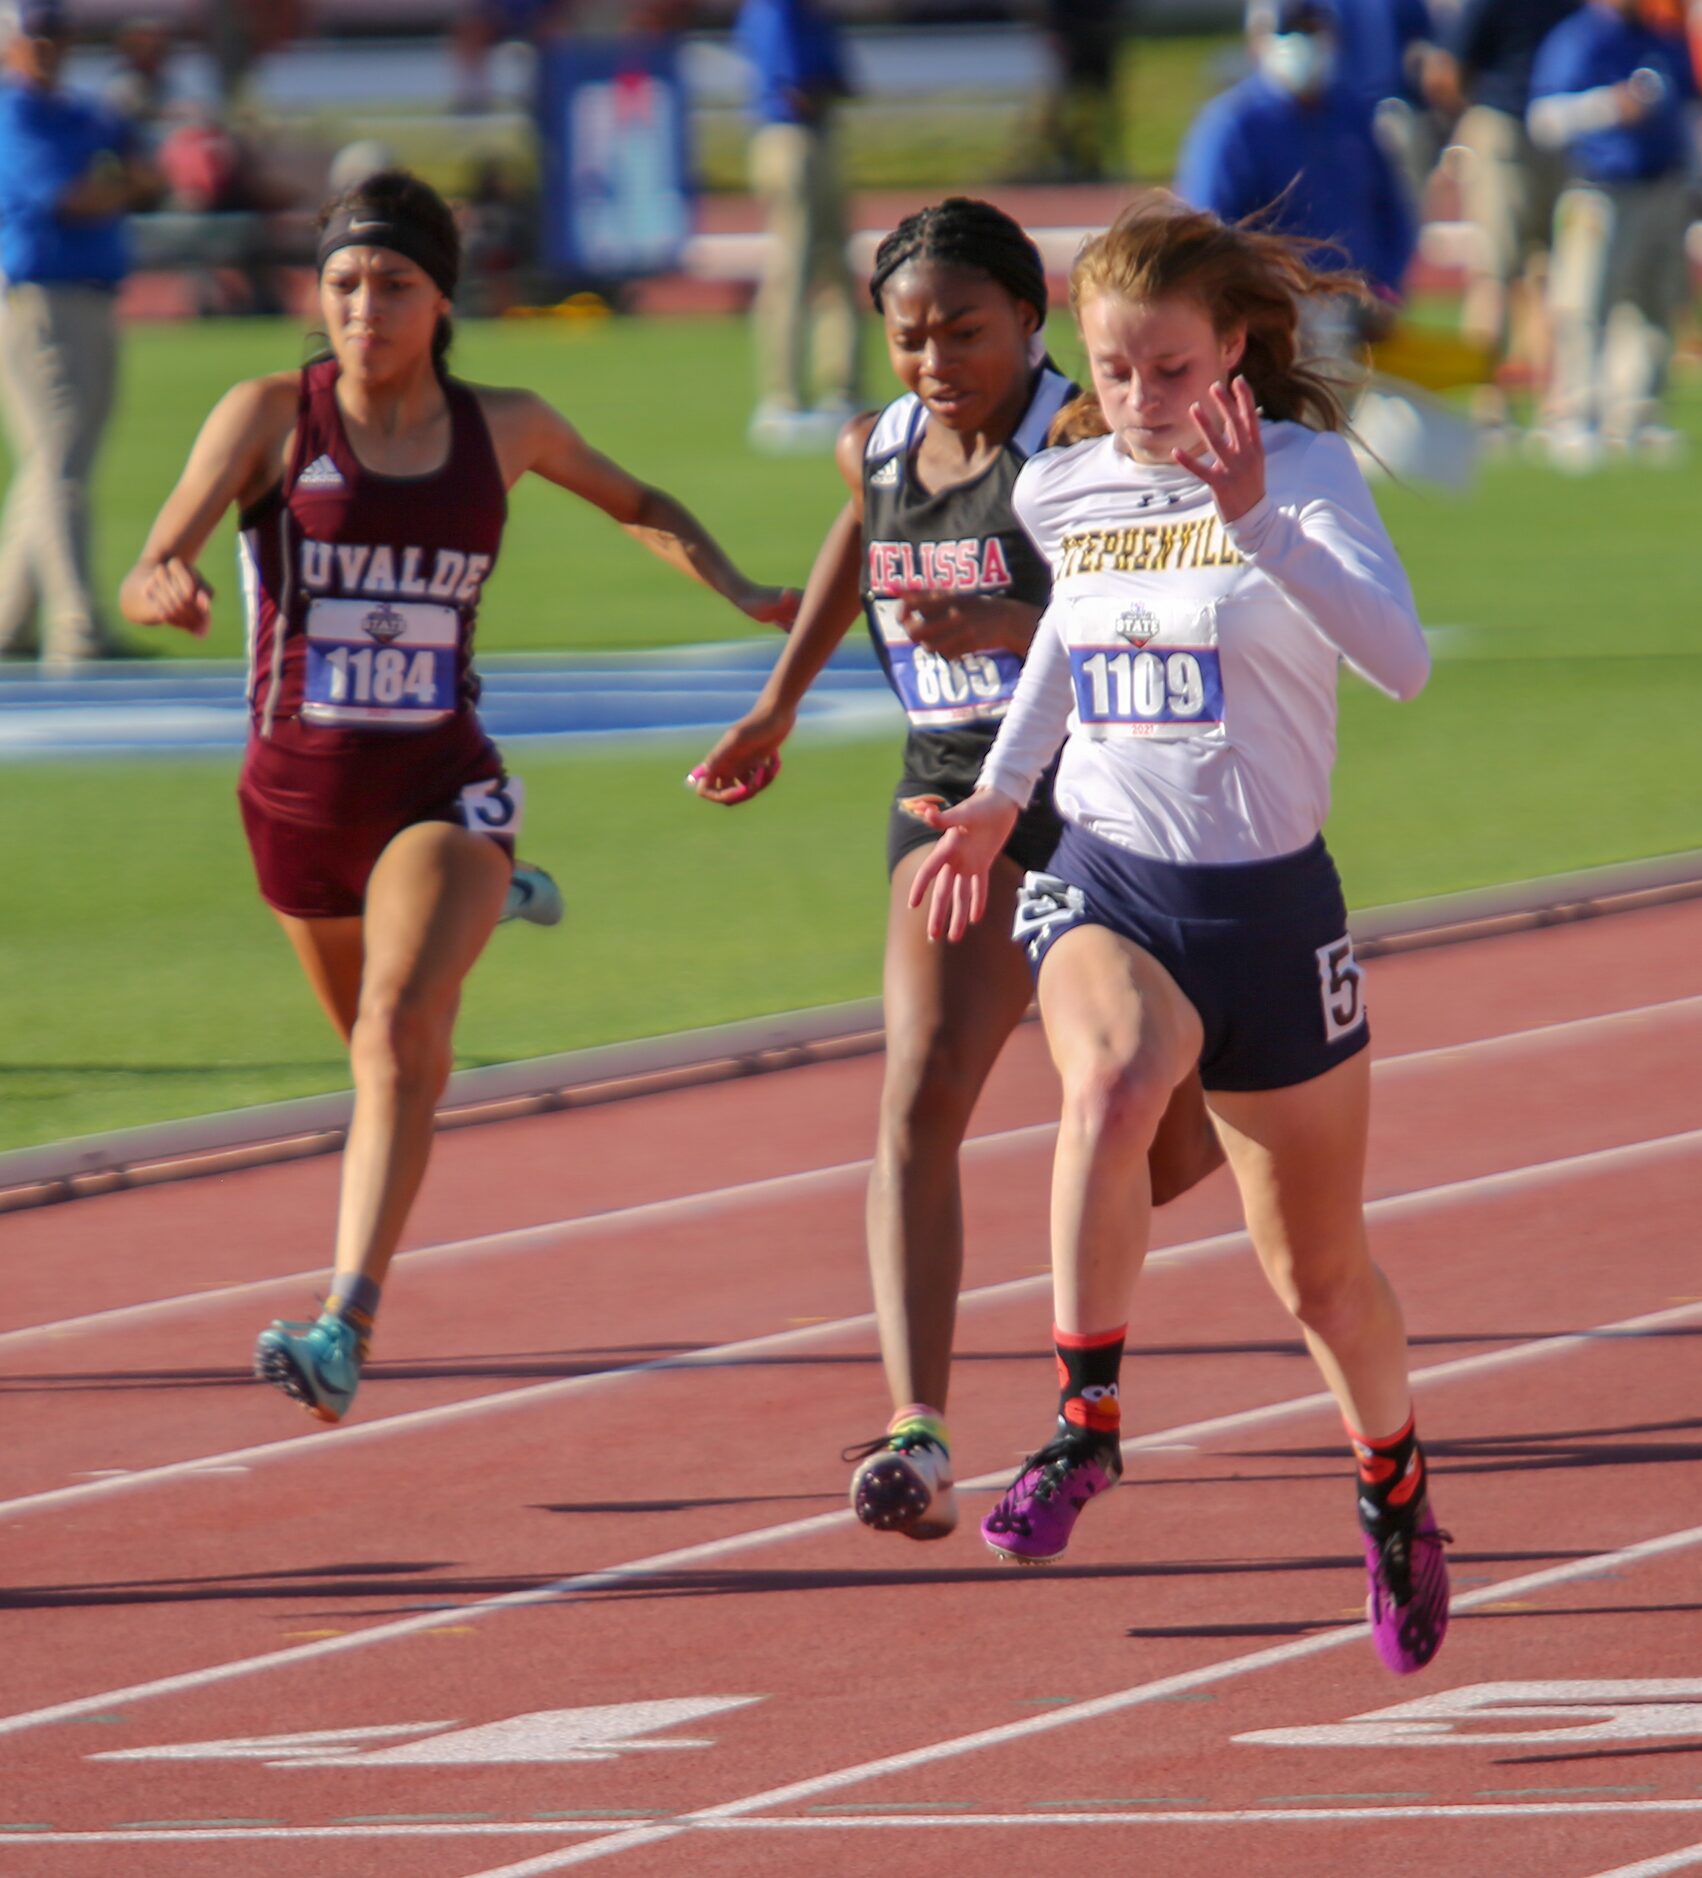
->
[1014, 824, 1371, 1089]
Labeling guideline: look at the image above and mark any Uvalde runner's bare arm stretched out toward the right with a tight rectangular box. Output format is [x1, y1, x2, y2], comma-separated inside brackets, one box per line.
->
[479, 389, 798, 627]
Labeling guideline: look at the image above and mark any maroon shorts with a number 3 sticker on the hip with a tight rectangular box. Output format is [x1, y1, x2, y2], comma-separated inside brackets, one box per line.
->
[237, 744, 520, 920]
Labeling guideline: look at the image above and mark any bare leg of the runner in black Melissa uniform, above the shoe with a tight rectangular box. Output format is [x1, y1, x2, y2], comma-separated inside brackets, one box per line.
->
[868, 847, 1033, 1410]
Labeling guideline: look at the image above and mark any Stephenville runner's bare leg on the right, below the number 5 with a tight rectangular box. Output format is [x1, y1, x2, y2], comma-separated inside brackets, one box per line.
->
[1208, 1050, 1411, 1437]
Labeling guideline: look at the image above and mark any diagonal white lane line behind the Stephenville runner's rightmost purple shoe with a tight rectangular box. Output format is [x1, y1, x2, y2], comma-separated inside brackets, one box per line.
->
[472, 1527, 1702, 1878]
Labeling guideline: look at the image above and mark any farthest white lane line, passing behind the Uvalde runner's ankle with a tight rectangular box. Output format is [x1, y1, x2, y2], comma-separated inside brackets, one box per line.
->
[0, 995, 1702, 1350]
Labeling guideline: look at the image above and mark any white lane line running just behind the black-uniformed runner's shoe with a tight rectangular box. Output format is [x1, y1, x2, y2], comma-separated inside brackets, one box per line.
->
[0, 1301, 1702, 1735]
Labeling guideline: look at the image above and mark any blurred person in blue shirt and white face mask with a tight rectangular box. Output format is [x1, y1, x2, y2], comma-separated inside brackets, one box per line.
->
[1176, 0, 1418, 299]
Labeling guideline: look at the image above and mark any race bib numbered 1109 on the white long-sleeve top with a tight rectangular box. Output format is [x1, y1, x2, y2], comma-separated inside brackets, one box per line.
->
[1069, 599, 1223, 740]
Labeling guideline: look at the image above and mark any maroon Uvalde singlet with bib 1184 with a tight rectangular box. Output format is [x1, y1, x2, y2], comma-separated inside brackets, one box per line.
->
[239, 359, 507, 837]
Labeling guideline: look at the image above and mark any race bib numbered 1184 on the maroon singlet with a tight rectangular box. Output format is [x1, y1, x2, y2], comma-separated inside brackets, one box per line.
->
[301, 599, 460, 731]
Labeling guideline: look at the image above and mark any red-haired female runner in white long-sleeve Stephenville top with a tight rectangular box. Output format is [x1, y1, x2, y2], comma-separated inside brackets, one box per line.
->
[913, 197, 1448, 1671]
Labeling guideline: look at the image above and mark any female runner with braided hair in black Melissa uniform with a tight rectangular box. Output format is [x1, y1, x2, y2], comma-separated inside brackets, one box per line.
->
[693, 197, 1221, 1538]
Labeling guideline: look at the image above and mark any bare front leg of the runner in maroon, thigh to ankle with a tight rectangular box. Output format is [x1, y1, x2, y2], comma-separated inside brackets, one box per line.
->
[336, 823, 511, 1285]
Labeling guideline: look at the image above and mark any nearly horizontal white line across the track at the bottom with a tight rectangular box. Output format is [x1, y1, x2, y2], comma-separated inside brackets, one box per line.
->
[0, 1799, 1702, 1840]
